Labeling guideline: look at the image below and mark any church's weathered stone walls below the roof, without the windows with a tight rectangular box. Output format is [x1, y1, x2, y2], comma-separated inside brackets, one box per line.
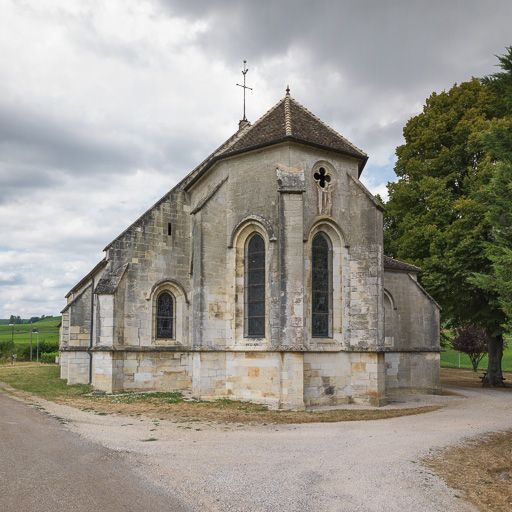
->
[61, 139, 439, 408]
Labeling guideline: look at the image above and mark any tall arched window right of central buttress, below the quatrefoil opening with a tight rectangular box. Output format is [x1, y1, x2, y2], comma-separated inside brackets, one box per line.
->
[311, 232, 332, 338]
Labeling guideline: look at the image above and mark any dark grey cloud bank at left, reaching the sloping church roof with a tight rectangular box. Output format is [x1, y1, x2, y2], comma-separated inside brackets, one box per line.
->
[0, 100, 208, 204]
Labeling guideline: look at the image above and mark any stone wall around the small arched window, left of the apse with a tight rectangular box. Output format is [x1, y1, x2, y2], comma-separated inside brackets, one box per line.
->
[106, 189, 191, 347]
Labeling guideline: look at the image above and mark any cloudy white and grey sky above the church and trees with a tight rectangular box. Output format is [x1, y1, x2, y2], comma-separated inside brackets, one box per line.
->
[0, 0, 512, 318]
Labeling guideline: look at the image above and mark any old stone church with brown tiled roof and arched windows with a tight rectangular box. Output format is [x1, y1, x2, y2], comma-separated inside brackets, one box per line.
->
[60, 90, 440, 409]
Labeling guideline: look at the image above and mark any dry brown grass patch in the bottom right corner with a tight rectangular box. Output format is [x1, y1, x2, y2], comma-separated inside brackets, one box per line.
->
[423, 432, 512, 512]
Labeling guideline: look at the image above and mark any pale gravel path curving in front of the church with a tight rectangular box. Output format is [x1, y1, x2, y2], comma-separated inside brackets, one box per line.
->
[14, 389, 512, 512]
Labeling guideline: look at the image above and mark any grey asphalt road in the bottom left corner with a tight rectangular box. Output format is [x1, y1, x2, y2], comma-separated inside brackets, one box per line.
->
[0, 392, 188, 512]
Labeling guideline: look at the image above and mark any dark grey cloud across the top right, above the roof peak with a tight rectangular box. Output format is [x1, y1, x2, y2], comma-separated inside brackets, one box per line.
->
[162, 0, 512, 90]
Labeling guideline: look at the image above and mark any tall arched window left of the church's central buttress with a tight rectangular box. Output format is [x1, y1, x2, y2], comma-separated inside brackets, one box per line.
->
[245, 233, 265, 338]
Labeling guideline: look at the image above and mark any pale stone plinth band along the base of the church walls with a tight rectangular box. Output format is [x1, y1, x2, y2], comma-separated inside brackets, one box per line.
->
[57, 348, 439, 409]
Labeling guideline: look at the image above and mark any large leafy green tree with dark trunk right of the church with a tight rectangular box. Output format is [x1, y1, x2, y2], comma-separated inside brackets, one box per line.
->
[385, 50, 508, 385]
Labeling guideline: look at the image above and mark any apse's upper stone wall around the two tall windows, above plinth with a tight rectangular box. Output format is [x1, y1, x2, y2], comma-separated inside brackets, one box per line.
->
[189, 144, 383, 350]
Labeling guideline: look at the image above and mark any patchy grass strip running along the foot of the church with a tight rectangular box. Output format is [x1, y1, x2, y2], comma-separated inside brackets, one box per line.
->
[0, 363, 439, 425]
